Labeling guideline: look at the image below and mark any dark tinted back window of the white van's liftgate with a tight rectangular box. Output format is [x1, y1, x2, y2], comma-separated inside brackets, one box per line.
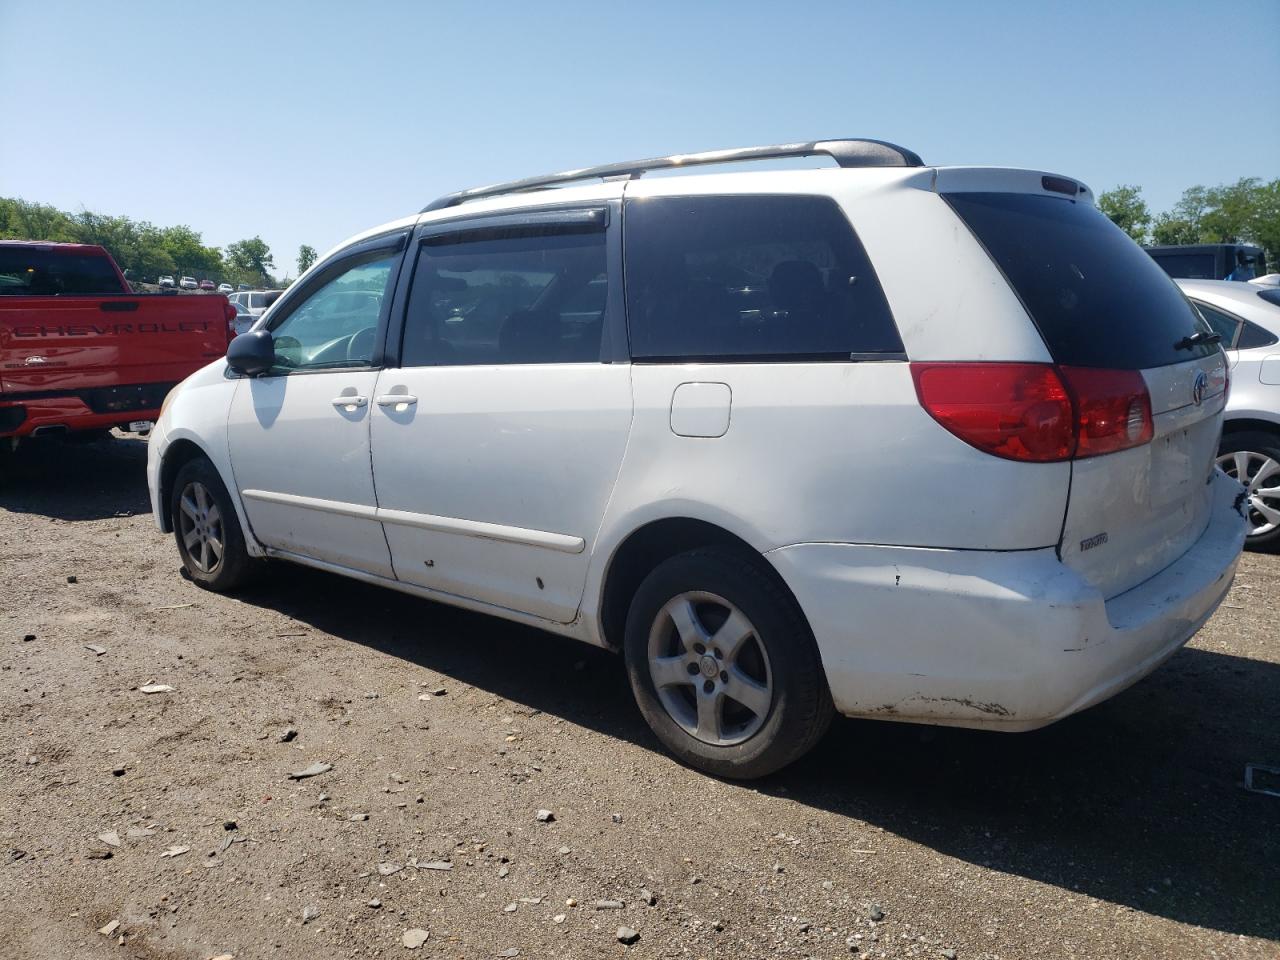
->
[943, 193, 1219, 370]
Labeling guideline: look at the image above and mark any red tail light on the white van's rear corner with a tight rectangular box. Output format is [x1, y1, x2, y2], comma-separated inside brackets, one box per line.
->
[911, 364, 1153, 463]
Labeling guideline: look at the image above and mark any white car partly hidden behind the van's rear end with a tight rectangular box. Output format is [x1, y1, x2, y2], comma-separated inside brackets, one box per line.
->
[1178, 280, 1280, 548]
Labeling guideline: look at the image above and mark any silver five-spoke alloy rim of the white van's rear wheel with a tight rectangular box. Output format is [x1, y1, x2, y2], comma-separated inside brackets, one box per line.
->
[648, 591, 773, 746]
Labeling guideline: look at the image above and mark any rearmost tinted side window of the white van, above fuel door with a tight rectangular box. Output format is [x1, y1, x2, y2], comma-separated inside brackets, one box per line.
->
[623, 196, 902, 361]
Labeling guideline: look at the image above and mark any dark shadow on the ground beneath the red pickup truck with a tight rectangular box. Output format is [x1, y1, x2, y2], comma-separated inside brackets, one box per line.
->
[0, 436, 151, 521]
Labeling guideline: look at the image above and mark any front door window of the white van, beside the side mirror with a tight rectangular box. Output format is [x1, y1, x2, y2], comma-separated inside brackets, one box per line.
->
[271, 253, 399, 374]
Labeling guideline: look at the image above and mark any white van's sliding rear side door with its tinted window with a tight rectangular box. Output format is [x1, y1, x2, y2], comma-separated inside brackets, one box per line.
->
[371, 202, 631, 623]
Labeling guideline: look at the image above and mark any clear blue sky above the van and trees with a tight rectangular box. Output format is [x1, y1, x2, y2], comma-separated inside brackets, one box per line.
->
[0, 0, 1280, 274]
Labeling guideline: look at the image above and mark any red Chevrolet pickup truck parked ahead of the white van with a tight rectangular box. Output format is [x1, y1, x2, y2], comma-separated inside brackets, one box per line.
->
[0, 241, 236, 445]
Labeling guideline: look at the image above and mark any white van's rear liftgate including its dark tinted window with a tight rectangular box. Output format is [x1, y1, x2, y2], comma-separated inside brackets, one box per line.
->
[943, 191, 1226, 598]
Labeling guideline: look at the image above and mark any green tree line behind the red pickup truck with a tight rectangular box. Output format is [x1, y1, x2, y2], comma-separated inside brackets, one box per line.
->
[0, 197, 316, 288]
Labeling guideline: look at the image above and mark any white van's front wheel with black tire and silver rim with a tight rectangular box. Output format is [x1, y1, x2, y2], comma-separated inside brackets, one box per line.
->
[169, 457, 261, 593]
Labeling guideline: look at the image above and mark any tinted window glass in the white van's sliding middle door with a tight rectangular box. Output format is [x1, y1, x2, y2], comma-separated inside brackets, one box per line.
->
[401, 230, 608, 366]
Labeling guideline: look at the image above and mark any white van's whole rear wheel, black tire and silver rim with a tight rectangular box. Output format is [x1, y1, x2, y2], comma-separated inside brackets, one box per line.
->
[623, 548, 835, 780]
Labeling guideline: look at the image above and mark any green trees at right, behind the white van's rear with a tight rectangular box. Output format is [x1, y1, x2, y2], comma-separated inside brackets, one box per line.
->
[1098, 177, 1280, 271]
